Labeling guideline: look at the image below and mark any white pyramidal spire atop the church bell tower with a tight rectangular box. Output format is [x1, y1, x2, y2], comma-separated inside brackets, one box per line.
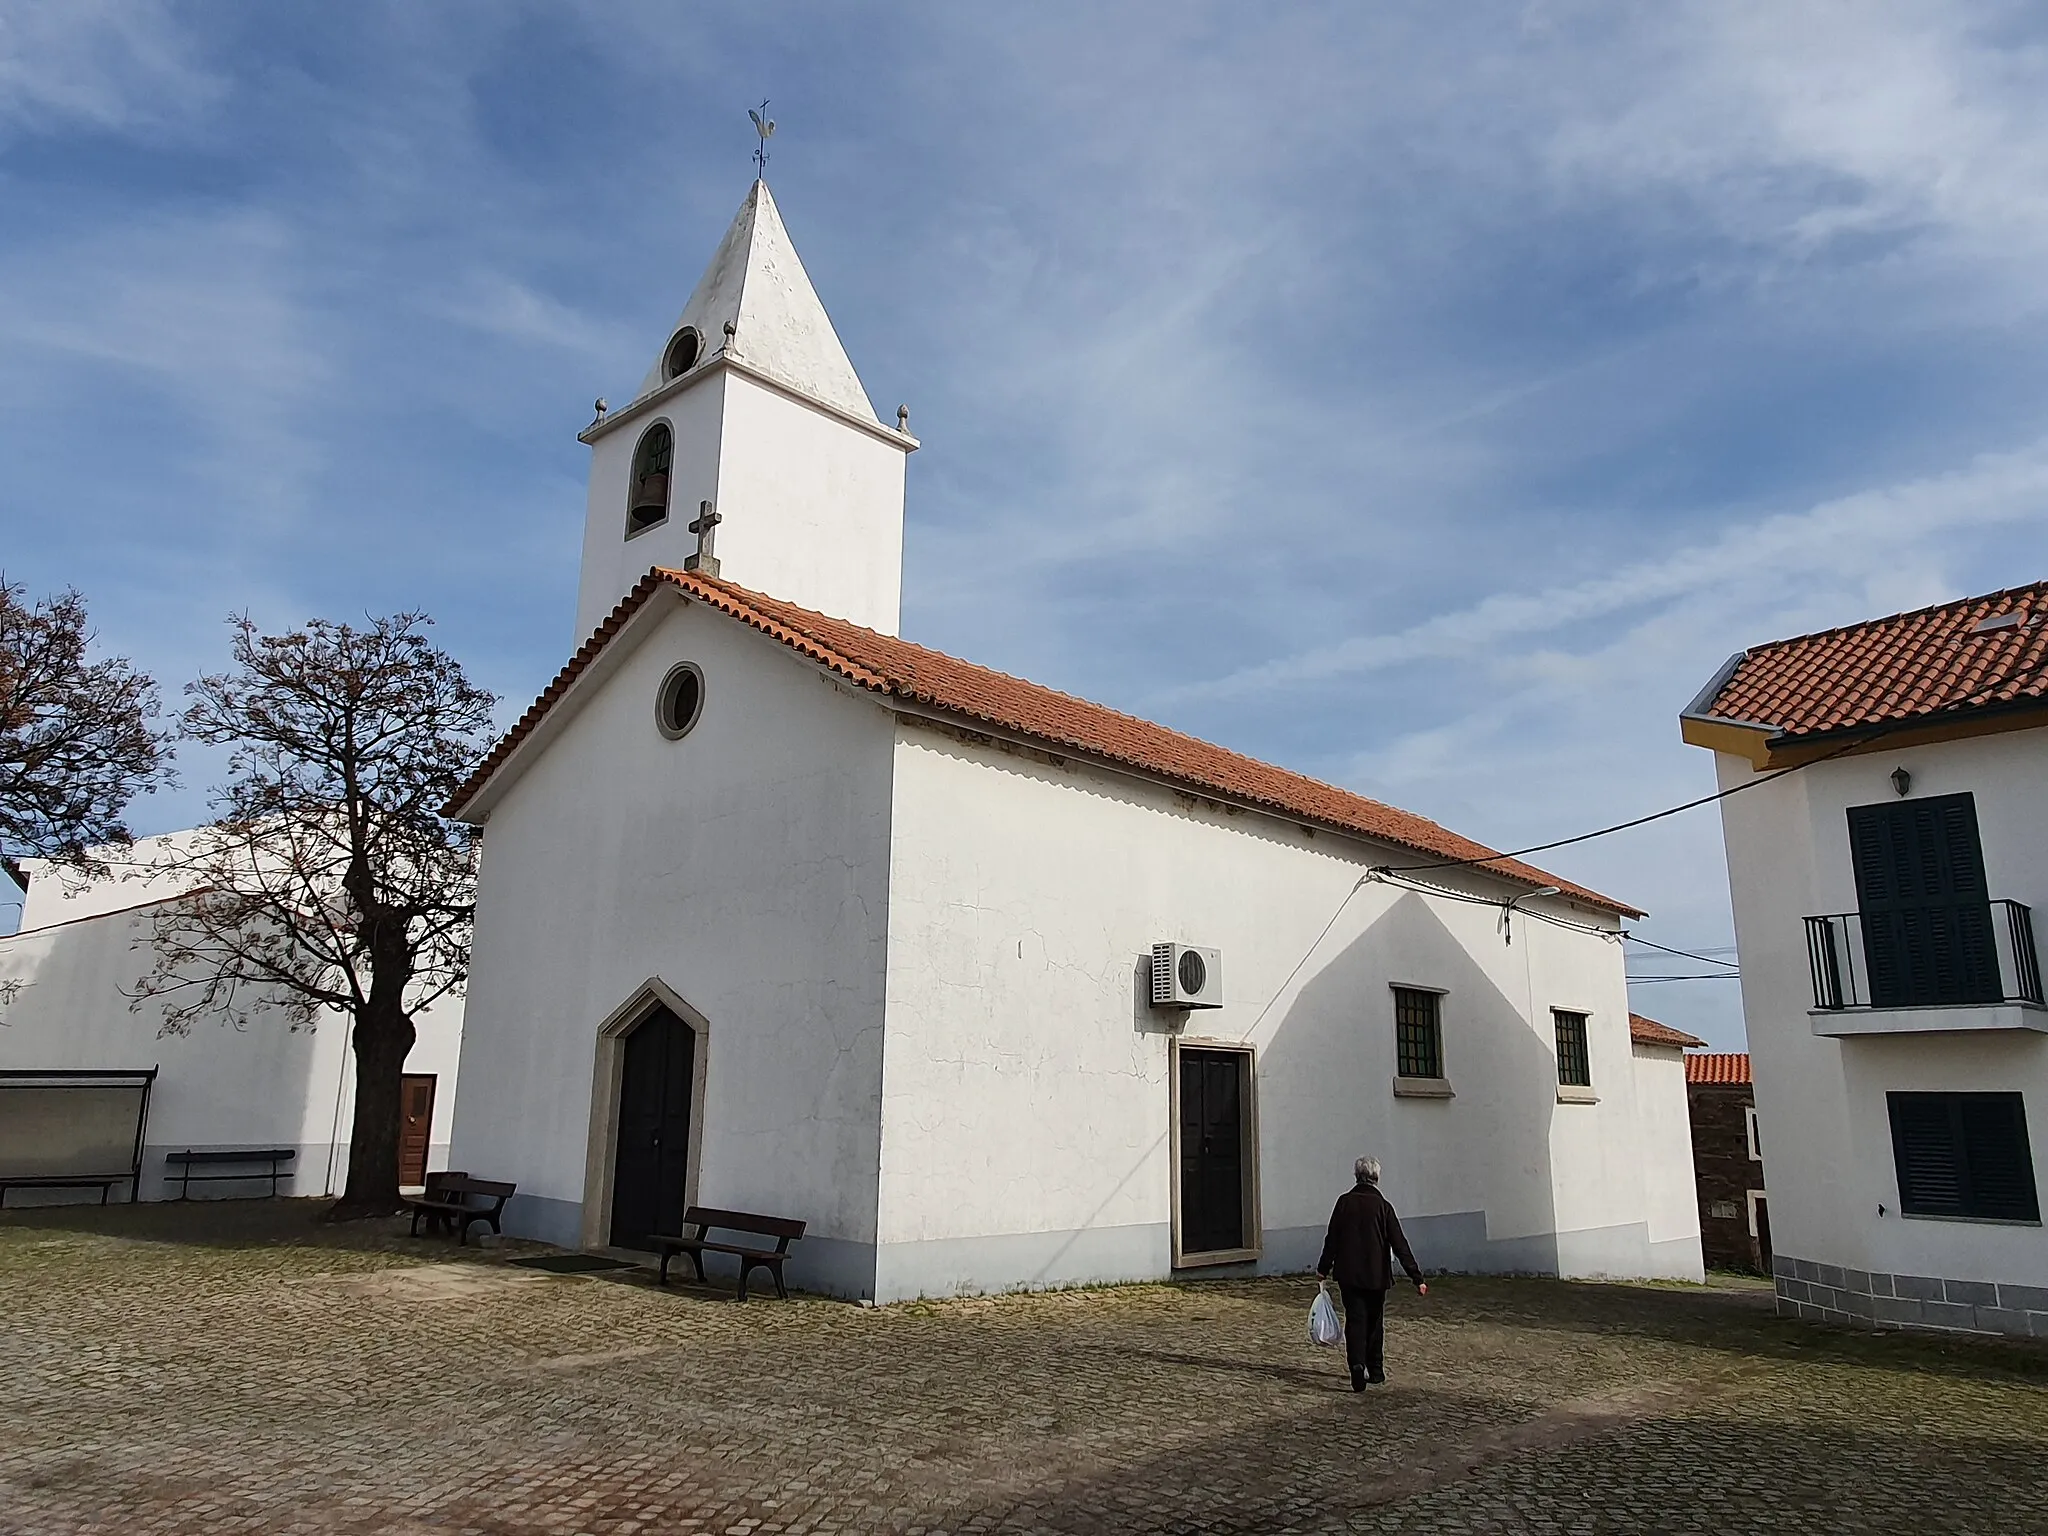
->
[641, 180, 874, 420]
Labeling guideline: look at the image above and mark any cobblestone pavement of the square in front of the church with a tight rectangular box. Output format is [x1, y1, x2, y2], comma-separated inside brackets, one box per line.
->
[0, 1202, 2048, 1536]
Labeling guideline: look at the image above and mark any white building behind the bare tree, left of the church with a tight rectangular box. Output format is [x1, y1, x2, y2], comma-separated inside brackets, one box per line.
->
[0, 834, 463, 1206]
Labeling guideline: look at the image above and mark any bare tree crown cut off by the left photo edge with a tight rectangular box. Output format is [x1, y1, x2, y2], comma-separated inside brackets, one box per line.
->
[0, 580, 170, 874]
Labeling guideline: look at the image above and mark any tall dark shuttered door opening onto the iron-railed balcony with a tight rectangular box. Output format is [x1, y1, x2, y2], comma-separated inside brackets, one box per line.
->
[1849, 795, 1999, 1008]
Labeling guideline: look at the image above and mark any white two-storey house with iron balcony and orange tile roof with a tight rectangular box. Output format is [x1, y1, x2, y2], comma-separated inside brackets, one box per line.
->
[1681, 584, 2048, 1335]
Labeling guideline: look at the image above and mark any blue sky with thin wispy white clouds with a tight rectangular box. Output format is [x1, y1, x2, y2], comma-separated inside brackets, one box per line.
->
[0, 0, 2048, 1044]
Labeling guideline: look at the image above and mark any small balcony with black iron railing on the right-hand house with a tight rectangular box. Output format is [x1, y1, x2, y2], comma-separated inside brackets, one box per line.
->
[1806, 901, 2048, 1036]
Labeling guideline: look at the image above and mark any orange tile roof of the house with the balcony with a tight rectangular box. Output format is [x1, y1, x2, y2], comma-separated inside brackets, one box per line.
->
[1688, 582, 2048, 737]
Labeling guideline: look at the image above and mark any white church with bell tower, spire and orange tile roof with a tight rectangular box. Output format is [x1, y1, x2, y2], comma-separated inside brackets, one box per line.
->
[451, 182, 1702, 1300]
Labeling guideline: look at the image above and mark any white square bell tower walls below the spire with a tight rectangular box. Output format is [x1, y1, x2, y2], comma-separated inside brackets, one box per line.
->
[573, 369, 905, 645]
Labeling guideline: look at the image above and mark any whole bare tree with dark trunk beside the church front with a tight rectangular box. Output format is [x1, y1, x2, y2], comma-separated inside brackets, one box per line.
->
[135, 612, 496, 1217]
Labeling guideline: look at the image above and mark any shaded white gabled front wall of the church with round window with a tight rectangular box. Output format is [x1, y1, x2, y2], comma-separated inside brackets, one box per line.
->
[453, 592, 891, 1294]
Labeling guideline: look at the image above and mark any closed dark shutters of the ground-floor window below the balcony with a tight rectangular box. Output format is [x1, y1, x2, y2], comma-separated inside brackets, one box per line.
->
[1884, 1094, 2042, 1221]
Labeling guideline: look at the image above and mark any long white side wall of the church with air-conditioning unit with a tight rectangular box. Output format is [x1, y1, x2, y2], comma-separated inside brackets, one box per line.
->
[877, 723, 1700, 1296]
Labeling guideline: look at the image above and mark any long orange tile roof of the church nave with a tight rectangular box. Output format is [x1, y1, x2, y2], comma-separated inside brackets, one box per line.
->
[446, 567, 1642, 918]
